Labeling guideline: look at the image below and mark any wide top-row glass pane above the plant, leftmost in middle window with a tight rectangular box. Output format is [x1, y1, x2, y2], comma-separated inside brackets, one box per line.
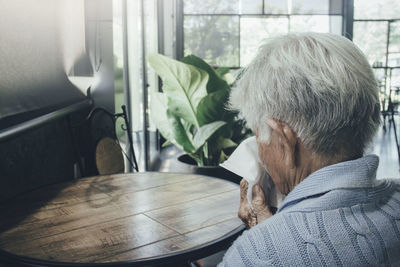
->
[183, 0, 239, 14]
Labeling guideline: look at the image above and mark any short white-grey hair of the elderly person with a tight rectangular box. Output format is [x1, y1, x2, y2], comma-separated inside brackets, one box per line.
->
[230, 32, 381, 156]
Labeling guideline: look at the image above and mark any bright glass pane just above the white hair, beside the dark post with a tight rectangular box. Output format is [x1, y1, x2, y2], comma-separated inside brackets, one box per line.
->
[290, 15, 342, 34]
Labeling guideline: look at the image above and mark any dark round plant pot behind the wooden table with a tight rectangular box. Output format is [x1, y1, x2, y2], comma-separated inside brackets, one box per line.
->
[176, 154, 242, 184]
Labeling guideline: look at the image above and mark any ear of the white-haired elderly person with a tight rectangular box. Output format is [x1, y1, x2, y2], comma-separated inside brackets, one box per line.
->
[266, 119, 297, 169]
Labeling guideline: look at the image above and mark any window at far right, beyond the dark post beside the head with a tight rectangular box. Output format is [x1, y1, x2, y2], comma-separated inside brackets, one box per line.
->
[353, 0, 400, 110]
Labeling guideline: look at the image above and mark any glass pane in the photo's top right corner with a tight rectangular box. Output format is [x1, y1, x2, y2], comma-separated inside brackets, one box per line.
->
[354, 0, 400, 19]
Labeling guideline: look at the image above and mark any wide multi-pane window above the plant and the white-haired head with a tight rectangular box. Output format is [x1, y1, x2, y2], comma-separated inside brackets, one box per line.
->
[181, 0, 343, 68]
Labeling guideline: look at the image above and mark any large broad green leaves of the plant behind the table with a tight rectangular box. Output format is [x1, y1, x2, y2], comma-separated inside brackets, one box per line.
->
[147, 54, 250, 183]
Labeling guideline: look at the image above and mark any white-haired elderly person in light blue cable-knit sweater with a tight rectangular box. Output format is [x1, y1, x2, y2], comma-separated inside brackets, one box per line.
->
[220, 33, 400, 266]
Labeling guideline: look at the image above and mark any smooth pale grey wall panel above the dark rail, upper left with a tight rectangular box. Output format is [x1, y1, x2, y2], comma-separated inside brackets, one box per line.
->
[0, 0, 85, 130]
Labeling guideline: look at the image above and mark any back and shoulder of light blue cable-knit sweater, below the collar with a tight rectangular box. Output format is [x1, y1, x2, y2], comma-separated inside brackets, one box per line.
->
[220, 188, 400, 266]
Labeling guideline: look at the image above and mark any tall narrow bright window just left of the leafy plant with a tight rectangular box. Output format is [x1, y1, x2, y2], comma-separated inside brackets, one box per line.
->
[113, 0, 158, 171]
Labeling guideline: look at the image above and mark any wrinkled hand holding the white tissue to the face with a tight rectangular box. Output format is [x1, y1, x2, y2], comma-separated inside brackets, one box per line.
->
[238, 179, 272, 228]
